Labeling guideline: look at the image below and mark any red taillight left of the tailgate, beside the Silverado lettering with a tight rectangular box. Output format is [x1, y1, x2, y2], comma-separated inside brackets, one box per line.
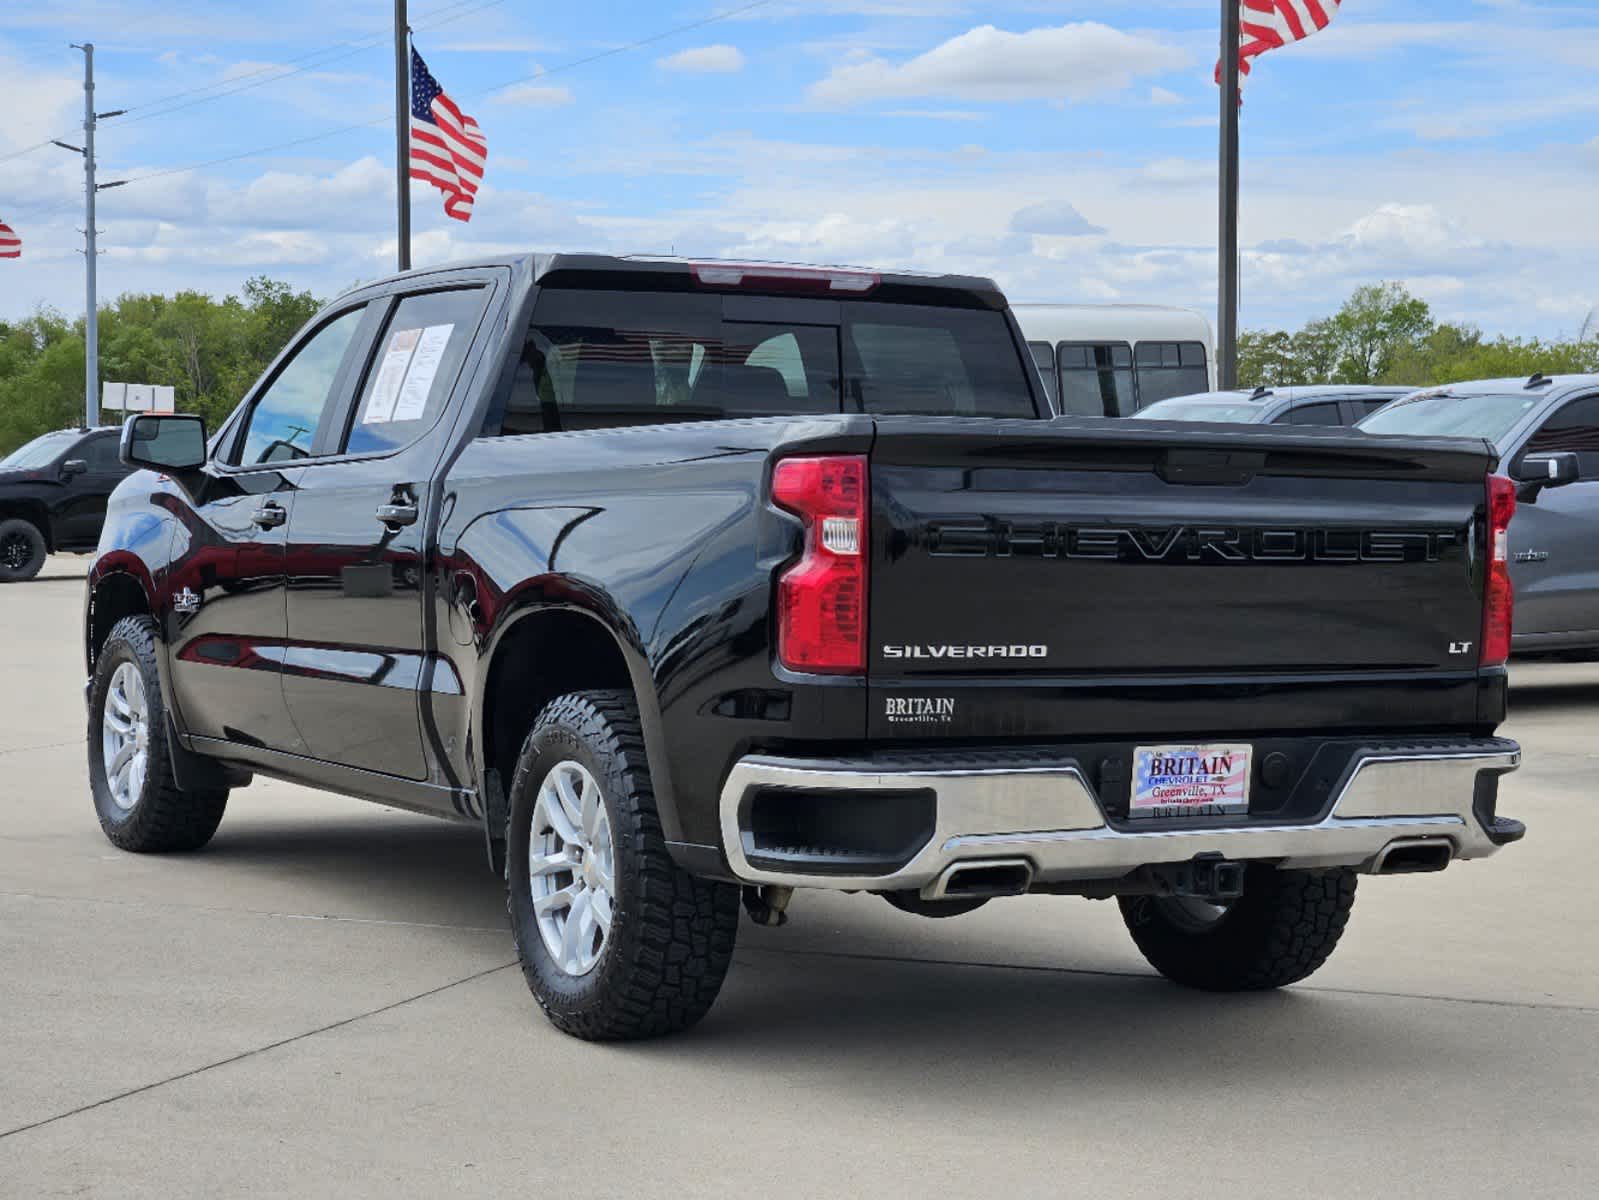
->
[772, 454, 867, 675]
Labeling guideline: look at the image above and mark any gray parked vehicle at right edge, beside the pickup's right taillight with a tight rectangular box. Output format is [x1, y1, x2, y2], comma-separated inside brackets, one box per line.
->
[1359, 374, 1599, 658]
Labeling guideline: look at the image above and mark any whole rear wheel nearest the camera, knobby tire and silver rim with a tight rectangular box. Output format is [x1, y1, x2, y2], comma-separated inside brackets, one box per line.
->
[505, 691, 739, 1042]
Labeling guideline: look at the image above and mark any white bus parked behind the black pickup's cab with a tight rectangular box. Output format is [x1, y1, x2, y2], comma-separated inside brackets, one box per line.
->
[1011, 304, 1215, 416]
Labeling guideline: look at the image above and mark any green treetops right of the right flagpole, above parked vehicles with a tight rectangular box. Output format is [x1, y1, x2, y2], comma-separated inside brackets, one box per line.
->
[1238, 283, 1599, 387]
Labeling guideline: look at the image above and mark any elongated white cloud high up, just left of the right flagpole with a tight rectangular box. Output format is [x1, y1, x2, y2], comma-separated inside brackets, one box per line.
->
[809, 21, 1188, 107]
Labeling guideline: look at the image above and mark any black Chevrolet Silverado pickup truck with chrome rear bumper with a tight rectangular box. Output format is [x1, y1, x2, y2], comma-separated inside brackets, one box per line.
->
[83, 254, 1524, 1038]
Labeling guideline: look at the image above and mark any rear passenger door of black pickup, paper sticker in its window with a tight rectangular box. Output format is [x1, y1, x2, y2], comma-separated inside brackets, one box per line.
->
[283, 272, 492, 779]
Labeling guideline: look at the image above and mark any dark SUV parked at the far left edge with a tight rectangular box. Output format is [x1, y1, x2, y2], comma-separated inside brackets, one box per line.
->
[0, 429, 128, 584]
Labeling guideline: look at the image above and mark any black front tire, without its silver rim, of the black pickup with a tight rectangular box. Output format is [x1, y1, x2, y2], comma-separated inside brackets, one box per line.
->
[88, 616, 227, 854]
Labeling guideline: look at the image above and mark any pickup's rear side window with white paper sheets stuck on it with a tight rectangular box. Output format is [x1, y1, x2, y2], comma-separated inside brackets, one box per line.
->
[344, 288, 484, 454]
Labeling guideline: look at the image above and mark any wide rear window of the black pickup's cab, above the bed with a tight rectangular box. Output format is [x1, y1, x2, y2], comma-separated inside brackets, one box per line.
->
[500, 288, 1038, 434]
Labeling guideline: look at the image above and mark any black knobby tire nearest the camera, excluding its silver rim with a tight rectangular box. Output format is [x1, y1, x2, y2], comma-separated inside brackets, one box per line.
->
[505, 691, 739, 1042]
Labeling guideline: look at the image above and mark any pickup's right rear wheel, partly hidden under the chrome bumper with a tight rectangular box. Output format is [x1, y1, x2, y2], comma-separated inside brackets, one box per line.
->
[1119, 864, 1354, 992]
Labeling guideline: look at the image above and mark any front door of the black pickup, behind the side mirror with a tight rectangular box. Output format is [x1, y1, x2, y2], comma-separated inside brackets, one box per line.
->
[166, 304, 369, 754]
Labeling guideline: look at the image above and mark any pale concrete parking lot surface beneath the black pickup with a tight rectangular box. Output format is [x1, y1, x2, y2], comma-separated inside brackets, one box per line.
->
[0, 558, 1599, 1200]
